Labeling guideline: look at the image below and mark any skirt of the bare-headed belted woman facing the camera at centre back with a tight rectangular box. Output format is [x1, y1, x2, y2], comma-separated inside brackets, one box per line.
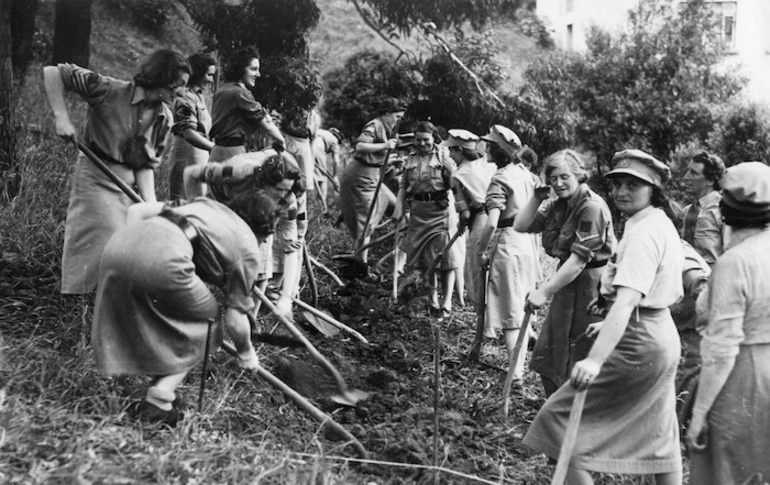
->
[401, 200, 463, 271]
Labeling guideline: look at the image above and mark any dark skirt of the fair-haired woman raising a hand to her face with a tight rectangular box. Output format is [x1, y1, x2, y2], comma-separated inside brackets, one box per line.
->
[530, 268, 604, 386]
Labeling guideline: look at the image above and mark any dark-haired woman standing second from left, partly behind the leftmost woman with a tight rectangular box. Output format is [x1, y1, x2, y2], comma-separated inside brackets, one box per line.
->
[168, 52, 217, 199]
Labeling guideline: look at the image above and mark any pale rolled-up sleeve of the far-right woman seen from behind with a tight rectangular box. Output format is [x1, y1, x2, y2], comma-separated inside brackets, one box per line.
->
[701, 255, 748, 365]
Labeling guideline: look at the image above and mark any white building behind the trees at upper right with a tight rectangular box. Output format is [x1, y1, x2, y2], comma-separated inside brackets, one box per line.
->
[537, 0, 770, 103]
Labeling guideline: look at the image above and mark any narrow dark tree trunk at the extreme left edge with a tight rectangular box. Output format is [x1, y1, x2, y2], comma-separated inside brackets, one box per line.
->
[0, 0, 20, 203]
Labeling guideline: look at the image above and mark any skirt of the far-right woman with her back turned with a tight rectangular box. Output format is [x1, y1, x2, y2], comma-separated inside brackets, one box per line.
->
[690, 344, 770, 485]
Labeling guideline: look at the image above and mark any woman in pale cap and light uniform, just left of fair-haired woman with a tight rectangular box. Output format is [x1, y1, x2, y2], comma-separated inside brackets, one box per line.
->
[477, 125, 540, 370]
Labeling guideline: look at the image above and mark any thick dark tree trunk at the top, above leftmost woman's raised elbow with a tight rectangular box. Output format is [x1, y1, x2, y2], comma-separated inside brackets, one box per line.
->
[53, 0, 92, 67]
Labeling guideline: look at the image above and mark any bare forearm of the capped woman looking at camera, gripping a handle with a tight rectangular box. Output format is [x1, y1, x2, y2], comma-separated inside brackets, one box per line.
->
[570, 286, 642, 390]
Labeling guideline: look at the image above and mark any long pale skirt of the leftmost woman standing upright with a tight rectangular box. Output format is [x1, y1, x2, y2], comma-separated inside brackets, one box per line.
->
[61, 155, 134, 294]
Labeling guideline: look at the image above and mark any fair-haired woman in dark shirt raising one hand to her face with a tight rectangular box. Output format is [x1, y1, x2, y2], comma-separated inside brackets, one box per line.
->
[513, 150, 616, 396]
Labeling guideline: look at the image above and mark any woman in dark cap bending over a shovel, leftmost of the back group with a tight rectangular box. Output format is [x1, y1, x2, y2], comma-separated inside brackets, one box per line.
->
[340, 98, 405, 261]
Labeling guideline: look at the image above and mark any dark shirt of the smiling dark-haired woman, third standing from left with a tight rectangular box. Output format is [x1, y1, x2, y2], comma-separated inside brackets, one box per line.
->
[209, 83, 267, 142]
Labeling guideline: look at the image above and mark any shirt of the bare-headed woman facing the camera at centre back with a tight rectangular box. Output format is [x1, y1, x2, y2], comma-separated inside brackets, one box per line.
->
[400, 146, 457, 195]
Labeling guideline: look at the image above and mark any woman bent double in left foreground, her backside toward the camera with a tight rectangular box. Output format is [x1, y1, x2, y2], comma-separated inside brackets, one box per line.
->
[92, 191, 277, 426]
